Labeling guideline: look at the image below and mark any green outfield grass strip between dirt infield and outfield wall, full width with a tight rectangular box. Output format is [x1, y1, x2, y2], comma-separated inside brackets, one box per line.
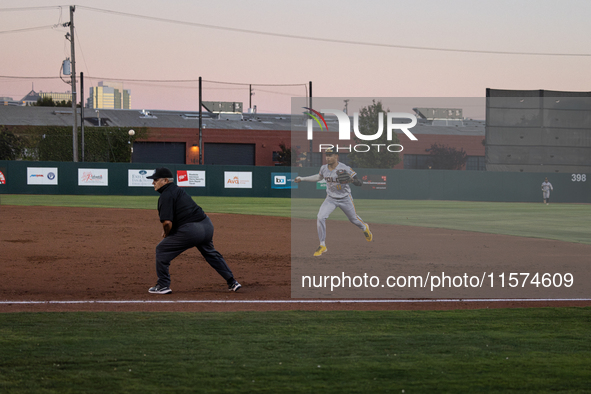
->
[0, 195, 591, 244]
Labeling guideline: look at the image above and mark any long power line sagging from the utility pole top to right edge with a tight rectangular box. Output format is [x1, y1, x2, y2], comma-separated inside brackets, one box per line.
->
[73, 6, 591, 57]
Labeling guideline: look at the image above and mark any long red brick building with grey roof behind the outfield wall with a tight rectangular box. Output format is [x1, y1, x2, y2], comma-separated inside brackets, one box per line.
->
[0, 106, 485, 170]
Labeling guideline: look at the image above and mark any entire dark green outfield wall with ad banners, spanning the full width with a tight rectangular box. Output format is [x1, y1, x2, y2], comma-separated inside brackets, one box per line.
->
[0, 161, 591, 203]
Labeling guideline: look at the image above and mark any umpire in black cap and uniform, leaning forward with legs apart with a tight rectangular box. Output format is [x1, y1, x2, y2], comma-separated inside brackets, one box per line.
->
[146, 167, 242, 294]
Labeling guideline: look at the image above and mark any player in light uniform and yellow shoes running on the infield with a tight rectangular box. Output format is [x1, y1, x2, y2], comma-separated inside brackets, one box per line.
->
[294, 149, 373, 256]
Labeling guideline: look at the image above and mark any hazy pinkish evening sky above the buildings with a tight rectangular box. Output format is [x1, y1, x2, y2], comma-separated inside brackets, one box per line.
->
[0, 0, 591, 116]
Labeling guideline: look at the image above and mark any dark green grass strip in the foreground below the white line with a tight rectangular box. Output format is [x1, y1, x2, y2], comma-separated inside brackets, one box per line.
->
[0, 308, 591, 393]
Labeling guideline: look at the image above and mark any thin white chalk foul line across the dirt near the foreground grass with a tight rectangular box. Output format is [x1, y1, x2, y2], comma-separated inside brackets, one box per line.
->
[0, 298, 591, 305]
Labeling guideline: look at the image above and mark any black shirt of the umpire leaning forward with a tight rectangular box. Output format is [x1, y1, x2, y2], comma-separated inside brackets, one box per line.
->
[158, 183, 206, 235]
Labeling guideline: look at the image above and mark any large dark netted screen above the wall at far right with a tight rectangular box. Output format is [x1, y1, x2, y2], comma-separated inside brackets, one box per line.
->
[486, 89, 591, 173]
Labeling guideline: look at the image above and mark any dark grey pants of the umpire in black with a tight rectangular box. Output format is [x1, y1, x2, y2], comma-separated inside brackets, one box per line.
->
[156, 217, 233, 287]
